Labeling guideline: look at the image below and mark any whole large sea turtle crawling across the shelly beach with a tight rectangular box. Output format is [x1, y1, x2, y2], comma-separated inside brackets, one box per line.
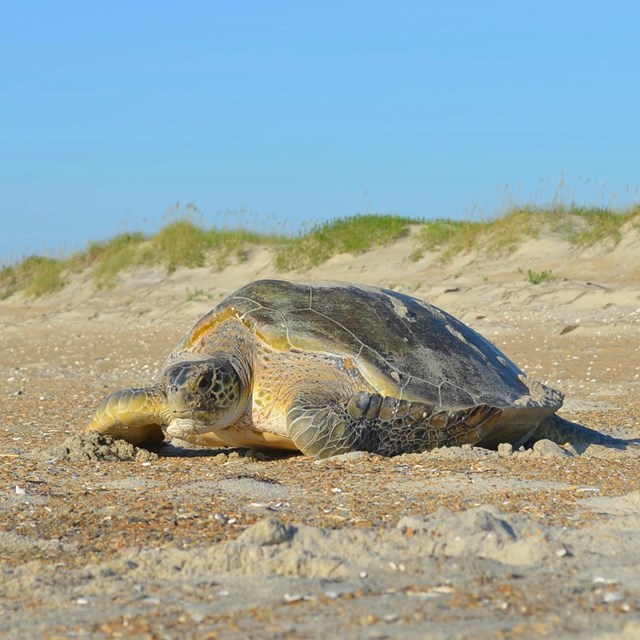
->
[88, 280, 607, 458]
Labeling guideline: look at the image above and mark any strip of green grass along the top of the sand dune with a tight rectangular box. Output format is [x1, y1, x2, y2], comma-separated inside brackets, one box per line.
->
[0, 204, 640, 299]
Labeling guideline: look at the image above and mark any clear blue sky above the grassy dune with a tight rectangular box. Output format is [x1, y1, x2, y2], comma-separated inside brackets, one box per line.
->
[0, 0, 640, 262]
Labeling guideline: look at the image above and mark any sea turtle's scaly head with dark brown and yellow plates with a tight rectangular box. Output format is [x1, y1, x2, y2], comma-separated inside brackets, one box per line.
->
[163, 353, 250, 432]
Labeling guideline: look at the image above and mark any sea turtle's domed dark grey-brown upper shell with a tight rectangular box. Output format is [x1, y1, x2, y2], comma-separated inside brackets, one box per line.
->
[178, 280, 561, 408]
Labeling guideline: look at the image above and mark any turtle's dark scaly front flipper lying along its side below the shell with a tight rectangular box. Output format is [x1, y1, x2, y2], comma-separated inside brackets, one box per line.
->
[287, 392, 502, 458]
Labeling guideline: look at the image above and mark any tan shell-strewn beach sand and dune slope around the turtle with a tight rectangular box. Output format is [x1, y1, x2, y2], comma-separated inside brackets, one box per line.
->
[0, 229, 640, 639]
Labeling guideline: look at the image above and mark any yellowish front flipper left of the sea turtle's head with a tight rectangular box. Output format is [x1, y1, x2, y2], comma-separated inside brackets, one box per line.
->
[87, 386, 170, 445]
